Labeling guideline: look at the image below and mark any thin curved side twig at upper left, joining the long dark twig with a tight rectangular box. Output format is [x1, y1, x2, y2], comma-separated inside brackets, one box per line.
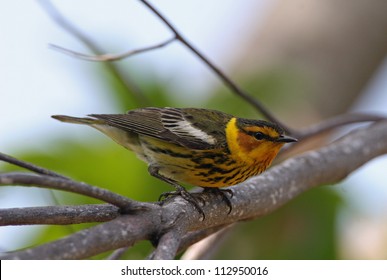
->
[49, 37, 176, 62]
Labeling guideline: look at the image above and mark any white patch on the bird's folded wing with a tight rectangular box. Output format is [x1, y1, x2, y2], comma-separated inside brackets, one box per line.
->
[162, 112, 216, 145]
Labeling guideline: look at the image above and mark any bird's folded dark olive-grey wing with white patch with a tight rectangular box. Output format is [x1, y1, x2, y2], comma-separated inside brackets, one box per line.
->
[90, 107, 229, 150]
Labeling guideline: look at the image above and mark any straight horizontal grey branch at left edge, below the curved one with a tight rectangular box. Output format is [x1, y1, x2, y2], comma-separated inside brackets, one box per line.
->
[0, 204, 120, 226]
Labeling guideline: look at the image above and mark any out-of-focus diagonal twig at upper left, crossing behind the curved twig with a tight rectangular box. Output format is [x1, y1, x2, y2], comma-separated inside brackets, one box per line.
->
[38, 0, 152, 107]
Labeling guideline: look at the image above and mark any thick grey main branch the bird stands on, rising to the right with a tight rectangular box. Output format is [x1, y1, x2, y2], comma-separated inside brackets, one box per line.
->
[1, 121, 387, 259]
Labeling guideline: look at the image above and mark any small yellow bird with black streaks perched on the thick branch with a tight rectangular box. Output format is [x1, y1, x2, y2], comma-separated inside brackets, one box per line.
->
[52, 107, 297, 219]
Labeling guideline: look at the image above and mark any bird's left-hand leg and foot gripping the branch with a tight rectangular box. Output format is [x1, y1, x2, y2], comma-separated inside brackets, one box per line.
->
[148, 165, 206, 220]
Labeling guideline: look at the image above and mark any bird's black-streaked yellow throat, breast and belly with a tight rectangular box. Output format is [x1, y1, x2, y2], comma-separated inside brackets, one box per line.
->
[140, 118, 280, 188]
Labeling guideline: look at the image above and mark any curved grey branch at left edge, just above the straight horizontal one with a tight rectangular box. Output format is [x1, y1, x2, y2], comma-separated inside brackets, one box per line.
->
[0, 172, 147, 212]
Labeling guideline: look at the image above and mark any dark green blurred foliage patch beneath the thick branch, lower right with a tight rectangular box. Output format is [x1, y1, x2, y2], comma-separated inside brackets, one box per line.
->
[215, 187, 341, 260]
